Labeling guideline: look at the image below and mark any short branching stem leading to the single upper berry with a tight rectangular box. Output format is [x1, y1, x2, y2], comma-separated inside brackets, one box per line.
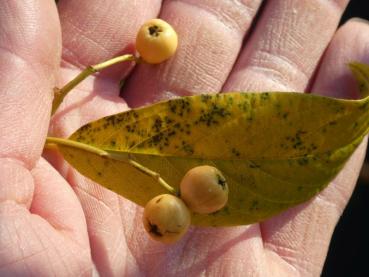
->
[51, 54, 139, 115]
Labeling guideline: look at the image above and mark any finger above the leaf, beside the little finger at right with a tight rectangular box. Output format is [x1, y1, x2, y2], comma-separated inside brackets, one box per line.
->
[223, 0, 348, 91]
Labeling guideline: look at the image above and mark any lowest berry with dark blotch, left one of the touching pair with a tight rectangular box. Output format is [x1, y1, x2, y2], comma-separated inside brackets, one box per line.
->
[143, 194, 191, 243]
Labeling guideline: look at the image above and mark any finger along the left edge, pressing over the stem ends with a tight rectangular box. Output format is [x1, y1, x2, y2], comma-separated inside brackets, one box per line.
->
[0, 1, 61, 168]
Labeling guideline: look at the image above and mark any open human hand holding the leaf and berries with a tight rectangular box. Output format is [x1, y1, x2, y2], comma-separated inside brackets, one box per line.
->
[0, 0, 369, 276]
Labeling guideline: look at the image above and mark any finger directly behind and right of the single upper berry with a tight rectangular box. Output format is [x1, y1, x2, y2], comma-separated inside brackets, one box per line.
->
[123, 0, 261, 107]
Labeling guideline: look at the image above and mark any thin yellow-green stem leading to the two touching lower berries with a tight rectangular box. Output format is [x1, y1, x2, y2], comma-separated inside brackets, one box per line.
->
[45, 137, 177, 194]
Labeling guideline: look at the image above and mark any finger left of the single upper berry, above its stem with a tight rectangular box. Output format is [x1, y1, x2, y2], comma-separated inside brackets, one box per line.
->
[58, 0, 161, 81]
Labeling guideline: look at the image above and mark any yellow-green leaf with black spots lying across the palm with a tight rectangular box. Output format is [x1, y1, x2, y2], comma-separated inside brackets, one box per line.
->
[54, 64, 369, 226]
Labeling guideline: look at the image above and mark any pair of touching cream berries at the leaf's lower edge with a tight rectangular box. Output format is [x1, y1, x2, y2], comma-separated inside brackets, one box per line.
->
[143, 165, 228, 243]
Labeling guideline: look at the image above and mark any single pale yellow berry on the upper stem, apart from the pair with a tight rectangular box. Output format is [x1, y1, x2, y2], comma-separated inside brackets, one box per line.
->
[136, 18, 178, 64]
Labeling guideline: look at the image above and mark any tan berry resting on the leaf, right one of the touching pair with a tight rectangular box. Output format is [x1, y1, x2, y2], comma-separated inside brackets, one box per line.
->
[180, 165, 228, 214]
